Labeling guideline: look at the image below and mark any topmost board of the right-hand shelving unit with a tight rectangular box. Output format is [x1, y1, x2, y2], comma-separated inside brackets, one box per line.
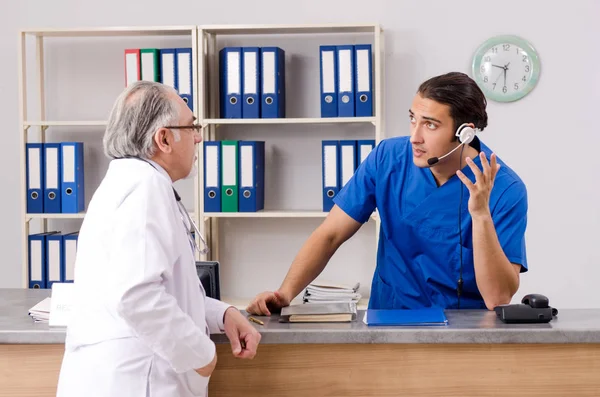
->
[199, 24, 382, 35]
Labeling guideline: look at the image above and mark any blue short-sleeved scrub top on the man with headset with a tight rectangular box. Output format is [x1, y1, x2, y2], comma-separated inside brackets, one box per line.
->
[334, 137, 527, 309]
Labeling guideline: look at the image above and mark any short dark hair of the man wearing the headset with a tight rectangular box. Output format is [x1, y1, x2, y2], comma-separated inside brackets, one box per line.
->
[418, 72, 487, 135]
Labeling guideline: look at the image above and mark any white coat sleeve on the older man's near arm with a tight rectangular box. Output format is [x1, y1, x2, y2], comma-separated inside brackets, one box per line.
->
[108, 176, 216, 373]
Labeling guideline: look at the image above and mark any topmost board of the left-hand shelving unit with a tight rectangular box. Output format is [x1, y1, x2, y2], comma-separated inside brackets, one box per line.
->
[21, 26, 196, 37]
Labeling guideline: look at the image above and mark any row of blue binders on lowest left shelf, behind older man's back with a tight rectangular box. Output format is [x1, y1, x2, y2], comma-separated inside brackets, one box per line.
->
[28, 231, 79, 289]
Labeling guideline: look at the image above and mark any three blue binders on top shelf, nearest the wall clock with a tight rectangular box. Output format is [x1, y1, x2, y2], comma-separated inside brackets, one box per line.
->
[319, 44, 373, 117]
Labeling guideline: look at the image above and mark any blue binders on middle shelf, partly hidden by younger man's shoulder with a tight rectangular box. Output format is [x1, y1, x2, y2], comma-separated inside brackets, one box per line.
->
[321, 139, 375, 212]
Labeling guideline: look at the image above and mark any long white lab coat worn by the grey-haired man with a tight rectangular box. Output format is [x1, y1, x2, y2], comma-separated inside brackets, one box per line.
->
[57, 159, 229, 397]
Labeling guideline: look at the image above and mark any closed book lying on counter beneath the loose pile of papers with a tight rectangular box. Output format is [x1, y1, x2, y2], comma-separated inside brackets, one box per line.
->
[279, 302, 356, 323]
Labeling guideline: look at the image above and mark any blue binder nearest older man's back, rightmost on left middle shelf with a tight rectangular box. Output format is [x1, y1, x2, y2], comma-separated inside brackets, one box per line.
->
[61, 142, 85, 214]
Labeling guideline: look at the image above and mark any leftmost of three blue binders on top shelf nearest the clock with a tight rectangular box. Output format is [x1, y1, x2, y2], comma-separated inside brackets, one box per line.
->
[319, 45, 338, 117]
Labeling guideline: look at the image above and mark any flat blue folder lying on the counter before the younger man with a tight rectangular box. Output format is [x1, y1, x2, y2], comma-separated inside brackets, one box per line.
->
[366, 307, 448, 326]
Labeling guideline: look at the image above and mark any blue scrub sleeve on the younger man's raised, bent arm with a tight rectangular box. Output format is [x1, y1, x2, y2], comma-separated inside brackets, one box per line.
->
[492, 182, 528, 273]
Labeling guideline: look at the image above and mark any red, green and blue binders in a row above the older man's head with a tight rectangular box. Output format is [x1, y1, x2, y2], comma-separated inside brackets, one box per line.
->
[125, 48, 194, 111]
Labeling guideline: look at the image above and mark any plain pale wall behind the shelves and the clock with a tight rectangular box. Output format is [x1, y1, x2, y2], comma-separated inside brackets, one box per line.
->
[0, 0, 600, 308]
